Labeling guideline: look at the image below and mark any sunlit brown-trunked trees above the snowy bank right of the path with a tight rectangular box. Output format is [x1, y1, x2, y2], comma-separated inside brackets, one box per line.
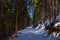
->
[31, 0, 60, 24]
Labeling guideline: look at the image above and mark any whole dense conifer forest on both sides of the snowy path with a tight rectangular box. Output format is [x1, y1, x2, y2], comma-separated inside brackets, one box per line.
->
[0, 0, 60, 40]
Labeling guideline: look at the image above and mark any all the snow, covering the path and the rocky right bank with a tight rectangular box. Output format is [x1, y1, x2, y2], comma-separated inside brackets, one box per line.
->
[14, 15, 60, 40]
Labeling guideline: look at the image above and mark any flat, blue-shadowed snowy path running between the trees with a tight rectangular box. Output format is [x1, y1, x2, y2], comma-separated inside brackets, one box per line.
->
[14, 27, 60, 40]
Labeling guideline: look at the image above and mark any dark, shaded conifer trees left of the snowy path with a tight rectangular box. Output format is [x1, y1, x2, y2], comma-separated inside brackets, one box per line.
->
[0, 0, 31, 40]
